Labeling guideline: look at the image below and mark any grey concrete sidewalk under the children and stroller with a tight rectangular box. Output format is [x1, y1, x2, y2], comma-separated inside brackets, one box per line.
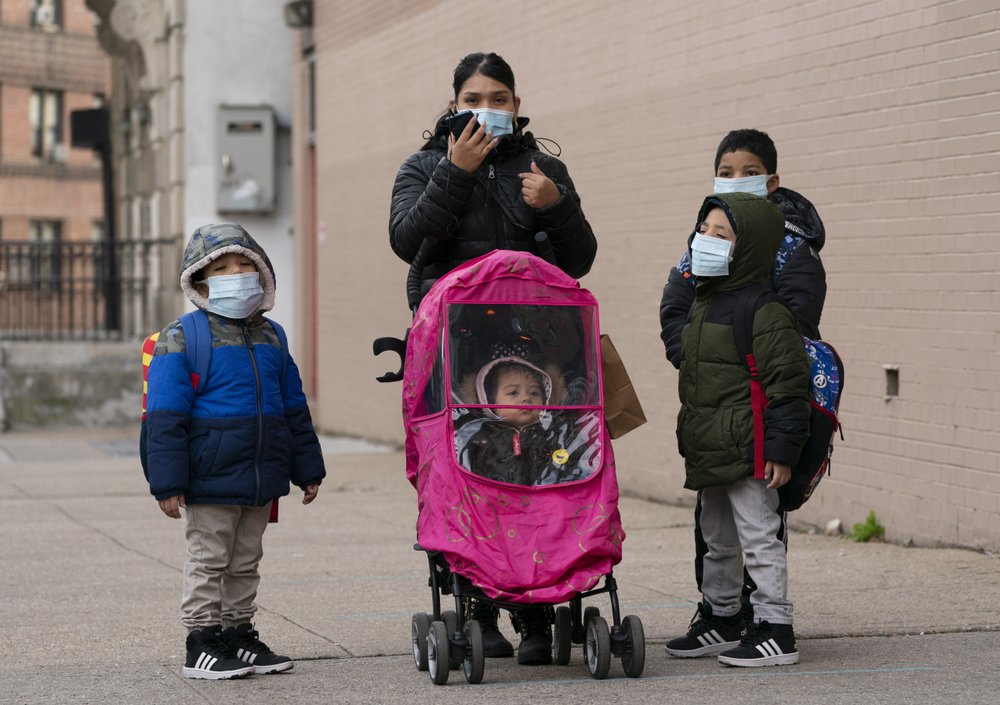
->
[0, 429, 1000, 703]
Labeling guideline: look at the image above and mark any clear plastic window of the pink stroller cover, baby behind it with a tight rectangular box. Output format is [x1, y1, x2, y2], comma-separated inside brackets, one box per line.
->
[447, 304, 602, 485]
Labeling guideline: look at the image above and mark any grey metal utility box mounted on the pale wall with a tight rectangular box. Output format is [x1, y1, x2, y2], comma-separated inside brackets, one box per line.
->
[215, 105, 275, 213]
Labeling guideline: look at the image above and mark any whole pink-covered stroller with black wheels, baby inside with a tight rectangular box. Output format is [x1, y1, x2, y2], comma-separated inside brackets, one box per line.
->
[376, 250, 645, 685]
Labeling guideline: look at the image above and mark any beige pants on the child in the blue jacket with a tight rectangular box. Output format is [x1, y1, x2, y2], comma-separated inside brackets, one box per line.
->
[181, 503, 271, 630]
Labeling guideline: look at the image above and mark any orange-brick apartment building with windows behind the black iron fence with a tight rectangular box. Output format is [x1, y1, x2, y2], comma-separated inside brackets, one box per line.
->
[0, 0, 110, 324]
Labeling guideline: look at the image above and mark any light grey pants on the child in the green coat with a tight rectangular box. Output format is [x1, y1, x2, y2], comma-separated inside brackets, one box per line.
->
[701, 477, 792, 624]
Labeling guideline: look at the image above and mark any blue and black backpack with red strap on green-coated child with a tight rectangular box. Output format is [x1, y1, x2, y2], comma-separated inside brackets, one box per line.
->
[733, 286, 844, 512]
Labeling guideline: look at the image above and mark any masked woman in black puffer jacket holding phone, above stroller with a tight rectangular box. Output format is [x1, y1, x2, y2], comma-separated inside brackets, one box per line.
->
[389, 53, 597, 291]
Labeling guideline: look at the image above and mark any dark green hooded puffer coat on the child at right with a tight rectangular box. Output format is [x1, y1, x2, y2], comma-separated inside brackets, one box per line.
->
[677, 193, 809, 490]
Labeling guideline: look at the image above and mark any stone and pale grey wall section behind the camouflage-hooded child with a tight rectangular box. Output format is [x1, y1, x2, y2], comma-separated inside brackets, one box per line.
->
[87, 0, 295, 338]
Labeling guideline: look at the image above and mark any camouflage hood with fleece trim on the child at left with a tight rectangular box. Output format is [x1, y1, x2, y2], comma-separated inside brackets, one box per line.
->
[181, 223, 274, 311]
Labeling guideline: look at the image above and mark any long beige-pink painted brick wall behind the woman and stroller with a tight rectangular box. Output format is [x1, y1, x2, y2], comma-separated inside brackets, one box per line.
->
[304, 0, 1000, 549]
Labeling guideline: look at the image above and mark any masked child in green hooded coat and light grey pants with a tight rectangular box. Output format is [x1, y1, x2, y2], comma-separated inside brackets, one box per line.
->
[666, 193, 809, 667]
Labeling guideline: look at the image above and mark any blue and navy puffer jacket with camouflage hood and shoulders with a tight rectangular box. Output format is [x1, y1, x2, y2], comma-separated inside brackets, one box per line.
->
[144, 223, 326, 506]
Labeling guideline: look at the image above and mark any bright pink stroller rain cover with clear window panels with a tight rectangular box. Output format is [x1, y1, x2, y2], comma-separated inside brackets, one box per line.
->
[403, 250, 625, 604]
